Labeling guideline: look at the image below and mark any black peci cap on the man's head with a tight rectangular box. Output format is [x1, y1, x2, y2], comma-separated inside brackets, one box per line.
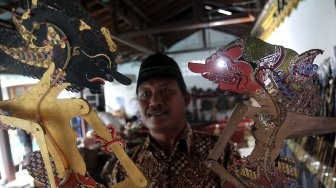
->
[136, 53, 187, 94]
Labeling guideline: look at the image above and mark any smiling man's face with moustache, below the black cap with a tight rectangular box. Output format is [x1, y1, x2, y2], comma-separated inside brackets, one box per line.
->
[138, 79, 190, 133]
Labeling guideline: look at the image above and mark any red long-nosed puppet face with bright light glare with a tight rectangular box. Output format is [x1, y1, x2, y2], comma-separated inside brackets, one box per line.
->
[188, 46, 261, 95]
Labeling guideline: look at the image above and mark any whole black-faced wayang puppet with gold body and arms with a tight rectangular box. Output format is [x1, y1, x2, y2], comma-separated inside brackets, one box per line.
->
[0, 0, 147, 187]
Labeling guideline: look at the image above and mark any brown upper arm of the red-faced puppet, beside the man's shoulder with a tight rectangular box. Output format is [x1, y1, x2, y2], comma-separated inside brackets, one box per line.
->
[207, 103, 247, 161]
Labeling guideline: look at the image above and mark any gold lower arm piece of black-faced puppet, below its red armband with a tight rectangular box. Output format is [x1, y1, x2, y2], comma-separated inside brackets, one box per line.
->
[111, 143, 147, 187]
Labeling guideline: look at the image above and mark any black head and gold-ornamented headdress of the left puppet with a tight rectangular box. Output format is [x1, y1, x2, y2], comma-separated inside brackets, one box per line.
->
[0, 0, 131, 92]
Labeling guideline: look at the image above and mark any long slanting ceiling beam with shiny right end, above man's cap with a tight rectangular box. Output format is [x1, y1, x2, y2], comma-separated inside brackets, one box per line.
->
[118, 15, 255, 39]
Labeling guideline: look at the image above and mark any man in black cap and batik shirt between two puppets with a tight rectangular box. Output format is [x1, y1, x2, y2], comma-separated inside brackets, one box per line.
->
[102, 53, 238, 188]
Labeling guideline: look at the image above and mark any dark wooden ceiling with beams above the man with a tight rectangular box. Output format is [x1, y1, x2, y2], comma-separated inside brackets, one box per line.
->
[0, 0, 268, 63]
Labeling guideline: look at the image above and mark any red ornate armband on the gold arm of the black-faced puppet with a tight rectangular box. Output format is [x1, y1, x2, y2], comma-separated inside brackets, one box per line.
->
[92, 124, 126, 155]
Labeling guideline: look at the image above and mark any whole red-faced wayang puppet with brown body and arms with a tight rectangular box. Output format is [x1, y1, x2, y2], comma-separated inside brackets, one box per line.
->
[188, 37, 336, 187]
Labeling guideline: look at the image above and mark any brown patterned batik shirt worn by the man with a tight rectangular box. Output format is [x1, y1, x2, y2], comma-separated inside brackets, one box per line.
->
[102, 126, 239, 188]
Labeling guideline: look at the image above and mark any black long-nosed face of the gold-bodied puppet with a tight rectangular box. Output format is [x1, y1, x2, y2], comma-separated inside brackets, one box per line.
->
[68, 24, 131, 92]
